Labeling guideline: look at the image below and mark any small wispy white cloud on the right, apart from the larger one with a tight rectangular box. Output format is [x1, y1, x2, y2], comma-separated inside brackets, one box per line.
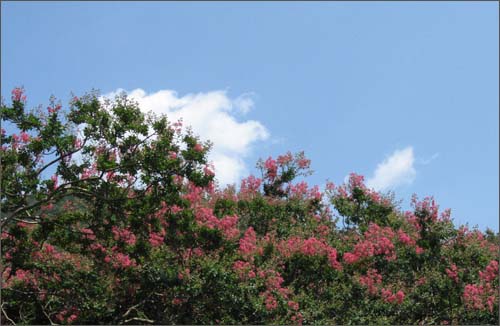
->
[366, 146, 417, 190]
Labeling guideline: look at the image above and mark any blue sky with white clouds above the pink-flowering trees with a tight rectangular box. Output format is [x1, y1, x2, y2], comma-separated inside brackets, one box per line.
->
[1, 2, 499, 230]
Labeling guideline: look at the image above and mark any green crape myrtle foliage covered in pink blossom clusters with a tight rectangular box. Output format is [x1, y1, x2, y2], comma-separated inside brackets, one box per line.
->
[0, 88, 499, 324]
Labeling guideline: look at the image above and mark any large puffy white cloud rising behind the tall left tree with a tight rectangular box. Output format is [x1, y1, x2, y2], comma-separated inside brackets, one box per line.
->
[104, 89, 269, 186]
